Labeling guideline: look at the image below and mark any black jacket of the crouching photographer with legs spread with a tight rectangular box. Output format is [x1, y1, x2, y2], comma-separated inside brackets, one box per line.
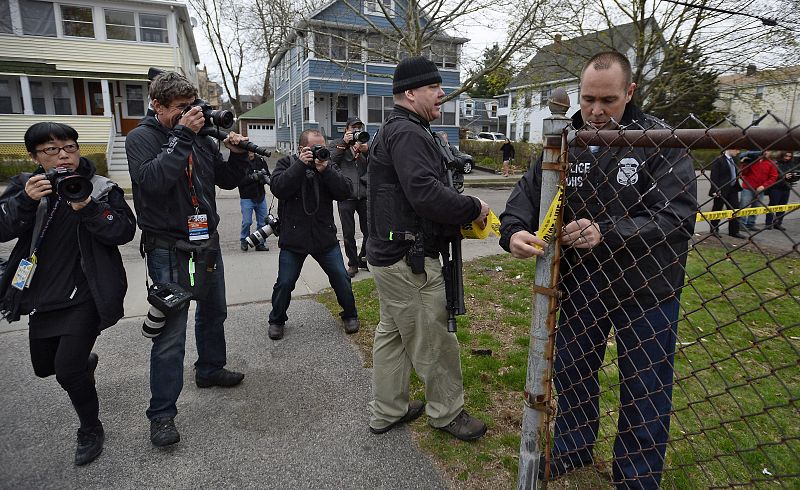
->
[270, 155, 350, 254]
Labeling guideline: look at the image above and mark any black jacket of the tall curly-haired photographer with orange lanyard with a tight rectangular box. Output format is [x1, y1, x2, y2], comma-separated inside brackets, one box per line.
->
[125, 115, 249, 241]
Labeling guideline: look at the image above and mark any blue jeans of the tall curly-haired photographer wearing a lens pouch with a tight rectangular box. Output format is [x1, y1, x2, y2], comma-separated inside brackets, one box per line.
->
[147, 248, 228, 420]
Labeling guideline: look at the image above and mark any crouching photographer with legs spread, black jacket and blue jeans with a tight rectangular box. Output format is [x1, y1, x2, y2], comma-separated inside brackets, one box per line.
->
[268, 129, 358, 340]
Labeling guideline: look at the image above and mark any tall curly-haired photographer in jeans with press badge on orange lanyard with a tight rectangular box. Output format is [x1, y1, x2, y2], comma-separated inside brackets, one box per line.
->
[125, 72, 248, 447]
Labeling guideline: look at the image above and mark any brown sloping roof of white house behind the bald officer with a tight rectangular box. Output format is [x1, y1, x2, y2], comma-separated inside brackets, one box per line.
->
[507, 18, 660, 90]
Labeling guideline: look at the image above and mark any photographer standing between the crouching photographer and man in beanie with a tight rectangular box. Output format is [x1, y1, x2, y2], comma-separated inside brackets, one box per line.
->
[331, 117, 369, 277]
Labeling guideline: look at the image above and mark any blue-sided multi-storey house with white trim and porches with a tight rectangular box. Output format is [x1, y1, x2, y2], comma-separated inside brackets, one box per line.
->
[270, 0, 468, 153]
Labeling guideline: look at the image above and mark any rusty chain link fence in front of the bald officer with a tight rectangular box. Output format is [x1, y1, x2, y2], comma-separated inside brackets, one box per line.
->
[519, 99, 800, 488]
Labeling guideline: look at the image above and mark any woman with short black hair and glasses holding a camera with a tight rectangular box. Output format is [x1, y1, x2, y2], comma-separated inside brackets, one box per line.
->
[0, 122, 135, 466]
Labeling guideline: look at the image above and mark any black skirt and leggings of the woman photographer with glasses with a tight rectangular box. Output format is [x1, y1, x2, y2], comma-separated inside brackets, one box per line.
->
[29, 303, 100, 429]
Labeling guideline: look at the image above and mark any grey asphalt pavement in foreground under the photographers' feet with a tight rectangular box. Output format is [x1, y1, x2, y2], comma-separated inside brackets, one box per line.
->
[0, 300, 447, 489]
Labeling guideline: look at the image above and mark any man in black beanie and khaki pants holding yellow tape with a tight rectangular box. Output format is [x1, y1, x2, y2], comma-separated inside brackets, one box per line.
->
[367, 57, 489, 441]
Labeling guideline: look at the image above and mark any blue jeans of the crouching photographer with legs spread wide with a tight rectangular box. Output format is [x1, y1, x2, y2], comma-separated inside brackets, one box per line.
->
[269, 243, 358, 325]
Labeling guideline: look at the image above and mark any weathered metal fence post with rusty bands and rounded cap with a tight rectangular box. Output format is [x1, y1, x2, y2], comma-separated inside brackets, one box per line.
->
[517, 88, 570, 490]
